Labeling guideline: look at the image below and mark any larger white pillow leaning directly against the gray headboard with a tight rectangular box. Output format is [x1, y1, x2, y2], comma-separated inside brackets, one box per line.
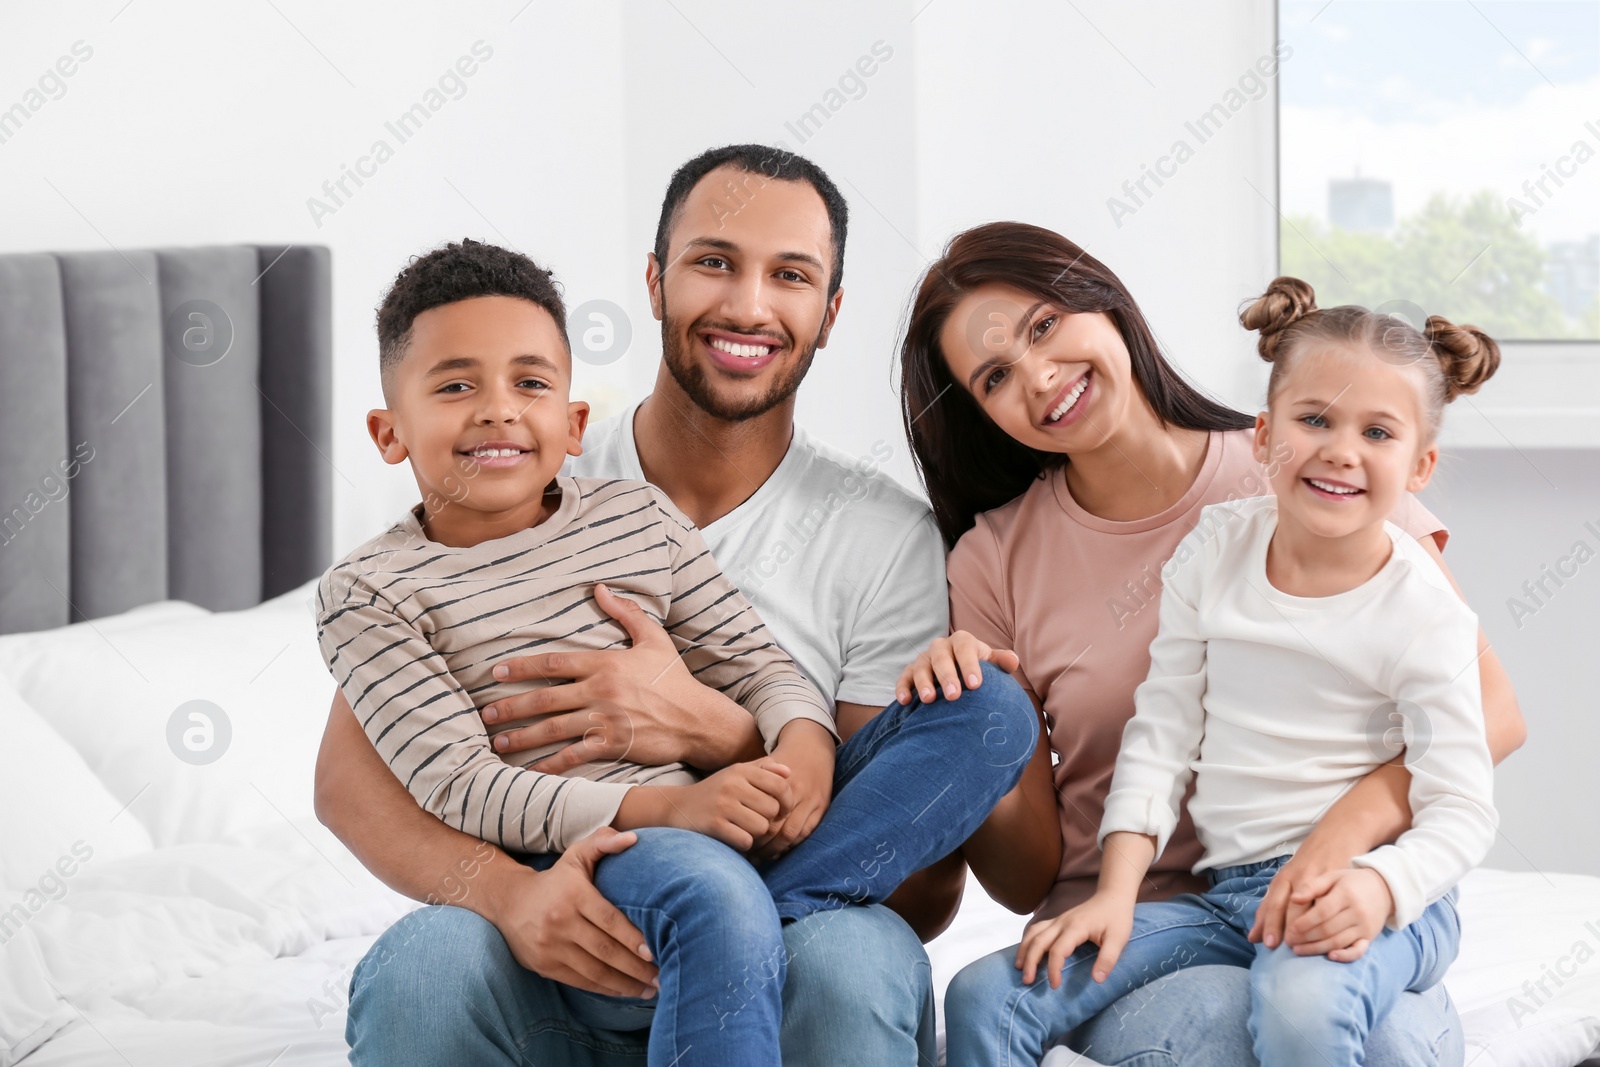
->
[0, 581, 333, 846]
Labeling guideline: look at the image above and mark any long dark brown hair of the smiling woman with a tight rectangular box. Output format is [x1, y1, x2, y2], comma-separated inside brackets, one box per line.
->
[901, 222, 1254, 547]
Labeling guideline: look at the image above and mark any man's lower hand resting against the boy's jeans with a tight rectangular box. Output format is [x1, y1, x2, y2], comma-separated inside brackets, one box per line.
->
[483, 827, 659, 998]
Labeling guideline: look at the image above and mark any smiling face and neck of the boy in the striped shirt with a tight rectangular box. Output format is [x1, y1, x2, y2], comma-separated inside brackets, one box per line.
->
[366, 296, 589, 545]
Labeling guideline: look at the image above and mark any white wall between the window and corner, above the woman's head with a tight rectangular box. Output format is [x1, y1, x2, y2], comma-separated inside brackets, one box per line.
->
[915, 0, 1293, 410]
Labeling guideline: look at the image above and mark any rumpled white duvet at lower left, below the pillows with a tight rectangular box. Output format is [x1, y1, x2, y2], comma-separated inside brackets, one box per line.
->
[0, 825, 413, 1067]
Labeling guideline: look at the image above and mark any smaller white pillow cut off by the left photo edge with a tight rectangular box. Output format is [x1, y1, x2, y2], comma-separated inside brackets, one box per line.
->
[0, 677, 150, 895]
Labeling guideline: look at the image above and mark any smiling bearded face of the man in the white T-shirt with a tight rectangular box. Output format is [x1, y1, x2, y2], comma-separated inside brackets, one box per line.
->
[645, 166, 843, 422]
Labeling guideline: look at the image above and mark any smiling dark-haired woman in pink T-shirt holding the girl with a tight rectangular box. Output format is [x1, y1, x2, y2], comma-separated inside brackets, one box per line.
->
[898, 222, 1523, 1067]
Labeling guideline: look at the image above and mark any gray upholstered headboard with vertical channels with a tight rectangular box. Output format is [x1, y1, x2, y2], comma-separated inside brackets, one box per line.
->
[0, 245, 333, 633]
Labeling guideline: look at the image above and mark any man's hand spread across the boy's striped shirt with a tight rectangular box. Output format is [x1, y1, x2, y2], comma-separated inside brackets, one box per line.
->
[482, 584, 762, 774]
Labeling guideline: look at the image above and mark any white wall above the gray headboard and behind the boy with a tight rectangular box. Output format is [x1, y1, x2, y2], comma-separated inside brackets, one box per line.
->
[0, 0, 637, 550]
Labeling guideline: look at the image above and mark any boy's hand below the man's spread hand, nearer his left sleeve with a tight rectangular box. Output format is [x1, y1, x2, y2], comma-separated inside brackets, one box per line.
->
[611, 757, 789, 853]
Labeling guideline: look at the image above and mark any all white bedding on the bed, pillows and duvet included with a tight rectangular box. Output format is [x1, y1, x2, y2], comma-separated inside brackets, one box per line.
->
[0, 587, 1600, 1067]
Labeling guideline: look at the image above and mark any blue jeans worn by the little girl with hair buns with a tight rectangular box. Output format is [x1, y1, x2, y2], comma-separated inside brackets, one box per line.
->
[944, 856, 1461, 1067]
